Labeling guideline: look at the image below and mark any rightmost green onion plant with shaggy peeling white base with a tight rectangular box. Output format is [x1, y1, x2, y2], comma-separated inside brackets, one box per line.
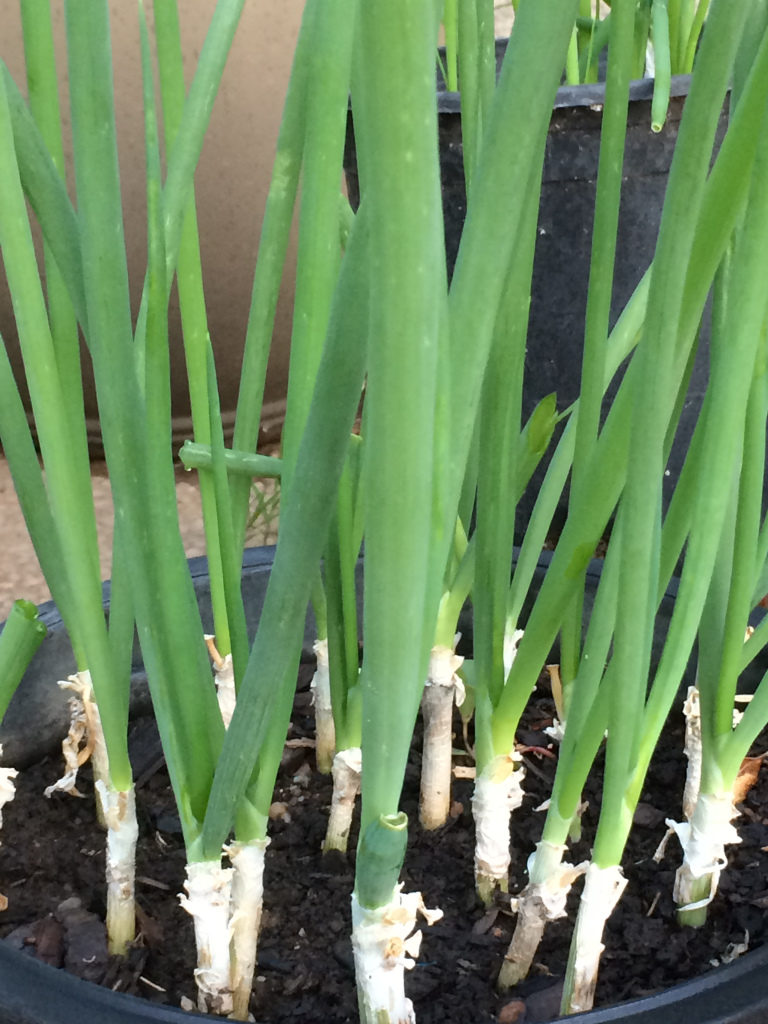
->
[673, 14, 767, 926]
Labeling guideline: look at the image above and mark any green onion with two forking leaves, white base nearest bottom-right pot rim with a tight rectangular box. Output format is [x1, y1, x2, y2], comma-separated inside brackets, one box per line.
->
[563, 5, 762, 1012]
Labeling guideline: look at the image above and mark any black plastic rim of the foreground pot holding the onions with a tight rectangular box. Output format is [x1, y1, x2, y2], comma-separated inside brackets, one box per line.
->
[0, 548, 768, 1024]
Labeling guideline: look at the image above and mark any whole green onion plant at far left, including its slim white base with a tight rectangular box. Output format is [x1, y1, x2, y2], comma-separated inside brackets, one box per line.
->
[0, 3, 141, 951]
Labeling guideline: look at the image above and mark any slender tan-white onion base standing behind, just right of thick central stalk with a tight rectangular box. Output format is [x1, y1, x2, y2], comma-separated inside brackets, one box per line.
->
[419, 645, 464, 829]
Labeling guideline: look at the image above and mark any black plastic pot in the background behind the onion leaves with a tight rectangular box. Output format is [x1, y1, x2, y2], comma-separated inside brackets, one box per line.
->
[344, 47, 727, 543]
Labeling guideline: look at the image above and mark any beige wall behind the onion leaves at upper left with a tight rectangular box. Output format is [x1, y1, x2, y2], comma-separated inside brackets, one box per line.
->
[0, 0, 303, 446]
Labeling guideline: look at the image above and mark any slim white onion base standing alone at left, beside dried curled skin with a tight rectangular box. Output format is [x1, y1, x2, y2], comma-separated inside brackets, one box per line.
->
[96, 779, 138, 955]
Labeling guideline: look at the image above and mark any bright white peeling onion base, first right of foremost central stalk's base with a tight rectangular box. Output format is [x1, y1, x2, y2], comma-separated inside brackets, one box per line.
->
[472, 751, 525, 903]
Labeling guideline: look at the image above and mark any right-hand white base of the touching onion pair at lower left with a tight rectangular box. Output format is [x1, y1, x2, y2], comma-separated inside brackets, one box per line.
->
[224, 839, 269, 1020]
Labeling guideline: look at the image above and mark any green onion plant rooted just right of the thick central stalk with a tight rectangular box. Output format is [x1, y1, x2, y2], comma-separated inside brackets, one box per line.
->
[466, 0, 641, 902]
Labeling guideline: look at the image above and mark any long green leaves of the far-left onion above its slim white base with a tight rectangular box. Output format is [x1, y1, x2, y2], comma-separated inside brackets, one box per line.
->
[0, 4, 140, 952]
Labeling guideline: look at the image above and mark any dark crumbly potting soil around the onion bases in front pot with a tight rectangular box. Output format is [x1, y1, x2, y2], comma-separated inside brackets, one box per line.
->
[0, 671, 768, 1024]
